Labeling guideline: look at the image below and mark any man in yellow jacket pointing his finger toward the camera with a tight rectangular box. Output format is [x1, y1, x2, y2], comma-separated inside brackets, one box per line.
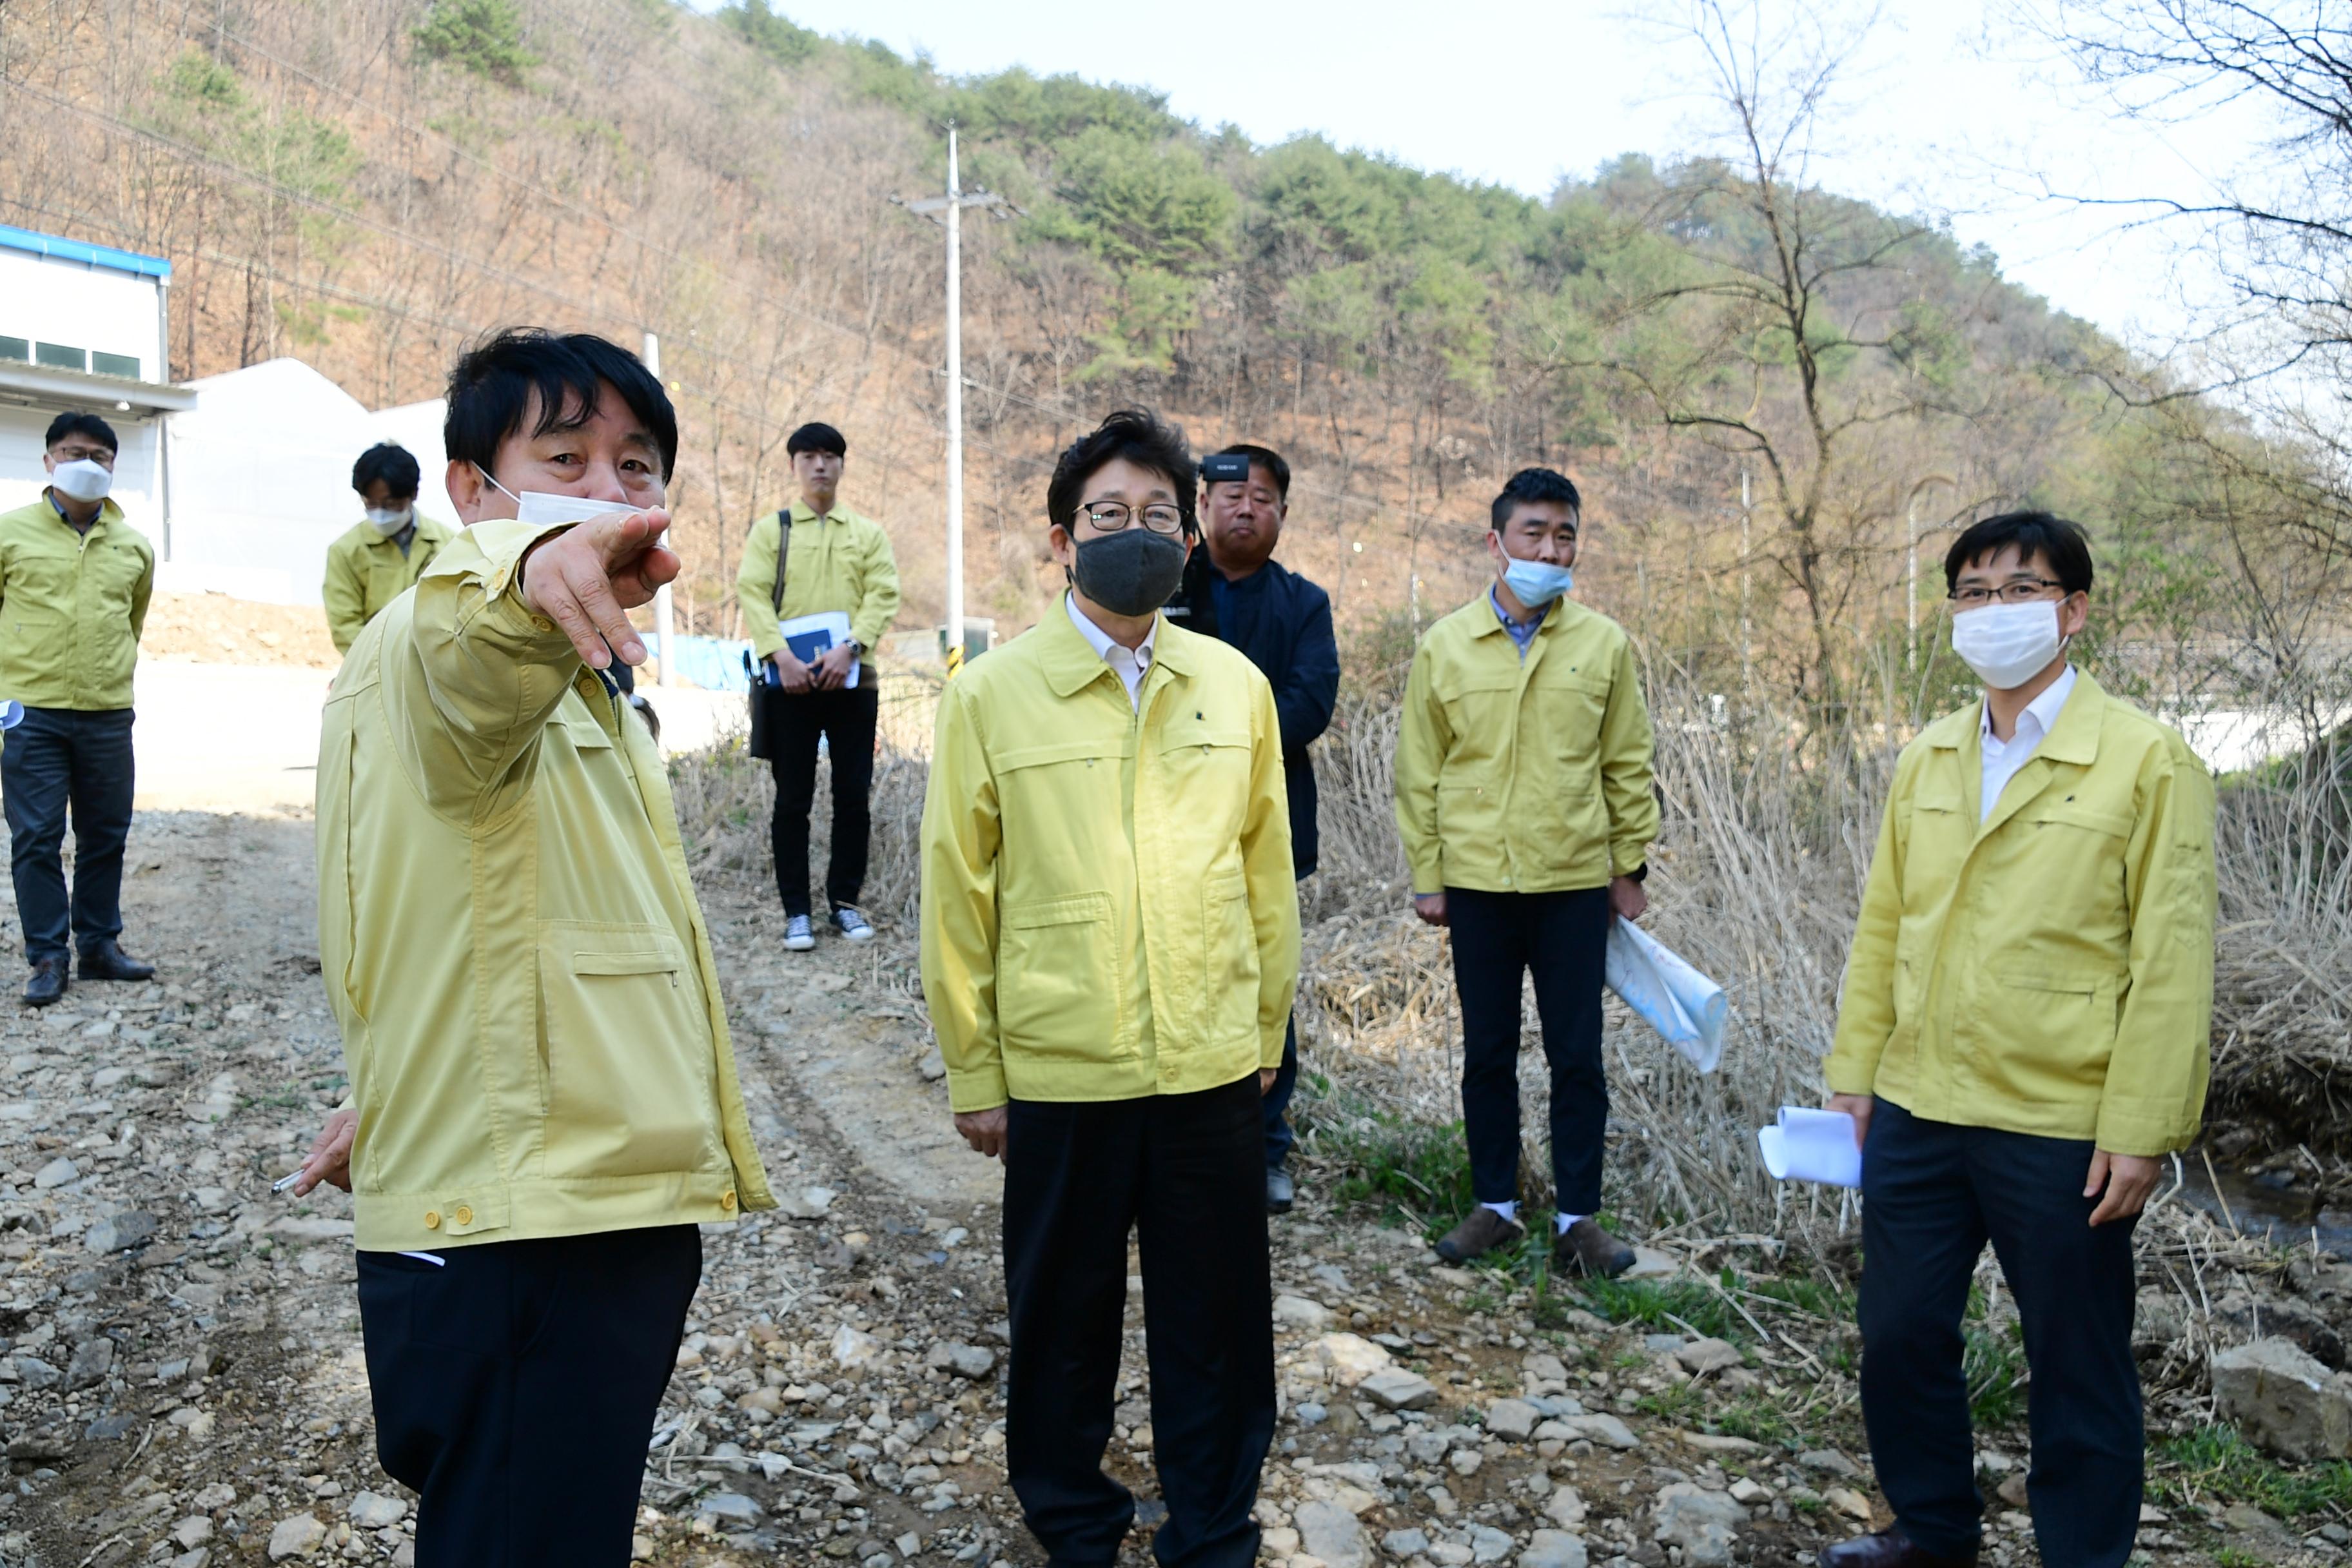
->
[299, 331, 774, 1568]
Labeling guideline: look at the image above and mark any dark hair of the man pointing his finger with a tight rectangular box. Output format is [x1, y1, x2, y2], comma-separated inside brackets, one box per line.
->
[442, 327, 678, 480]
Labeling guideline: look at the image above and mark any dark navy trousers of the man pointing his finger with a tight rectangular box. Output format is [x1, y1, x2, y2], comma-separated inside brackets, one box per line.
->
[360, 1225, 703, 1568]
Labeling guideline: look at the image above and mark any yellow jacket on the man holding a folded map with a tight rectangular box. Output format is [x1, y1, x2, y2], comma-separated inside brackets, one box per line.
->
[1397, 593, 1658, 894]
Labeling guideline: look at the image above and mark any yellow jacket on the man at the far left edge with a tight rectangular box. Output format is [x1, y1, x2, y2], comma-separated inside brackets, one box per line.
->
[0, 491, 155, 712]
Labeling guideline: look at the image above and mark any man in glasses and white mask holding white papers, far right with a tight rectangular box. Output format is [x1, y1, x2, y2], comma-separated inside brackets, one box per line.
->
[1821, 513, 2213, 1568]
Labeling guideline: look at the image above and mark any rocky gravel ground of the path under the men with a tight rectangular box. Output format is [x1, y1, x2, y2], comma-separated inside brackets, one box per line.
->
[0, 814, 2342, 1568]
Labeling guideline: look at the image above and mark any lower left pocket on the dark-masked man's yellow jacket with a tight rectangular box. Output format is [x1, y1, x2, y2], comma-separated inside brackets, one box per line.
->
[997, 894, 1119, 1063]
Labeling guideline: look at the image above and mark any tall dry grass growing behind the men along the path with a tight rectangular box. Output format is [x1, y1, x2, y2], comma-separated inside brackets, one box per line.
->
[675, 672, 2352, 1262]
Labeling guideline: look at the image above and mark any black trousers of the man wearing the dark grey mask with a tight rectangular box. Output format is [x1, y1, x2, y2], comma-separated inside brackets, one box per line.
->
[1004, 1072, 1275, 1568]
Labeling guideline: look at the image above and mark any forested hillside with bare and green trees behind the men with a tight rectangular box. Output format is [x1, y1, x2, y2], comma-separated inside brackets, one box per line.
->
[0, 0, 2324, 710]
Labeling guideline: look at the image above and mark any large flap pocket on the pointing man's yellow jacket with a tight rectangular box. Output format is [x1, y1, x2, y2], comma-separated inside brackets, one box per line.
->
[538, 921, 718, 1178]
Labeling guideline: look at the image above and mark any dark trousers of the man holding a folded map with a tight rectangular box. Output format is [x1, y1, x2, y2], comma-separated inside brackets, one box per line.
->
[1447, 887, 1609, 1213]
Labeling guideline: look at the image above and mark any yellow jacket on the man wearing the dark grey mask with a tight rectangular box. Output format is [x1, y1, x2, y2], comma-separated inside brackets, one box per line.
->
[917, 602, 1298, 1112]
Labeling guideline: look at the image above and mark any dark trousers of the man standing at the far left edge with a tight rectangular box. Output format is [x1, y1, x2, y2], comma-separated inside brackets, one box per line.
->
[0, 707, 134, 964]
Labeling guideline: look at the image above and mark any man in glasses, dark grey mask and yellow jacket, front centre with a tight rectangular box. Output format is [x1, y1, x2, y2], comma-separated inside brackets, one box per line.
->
[922, 411, 1298, 1568]
